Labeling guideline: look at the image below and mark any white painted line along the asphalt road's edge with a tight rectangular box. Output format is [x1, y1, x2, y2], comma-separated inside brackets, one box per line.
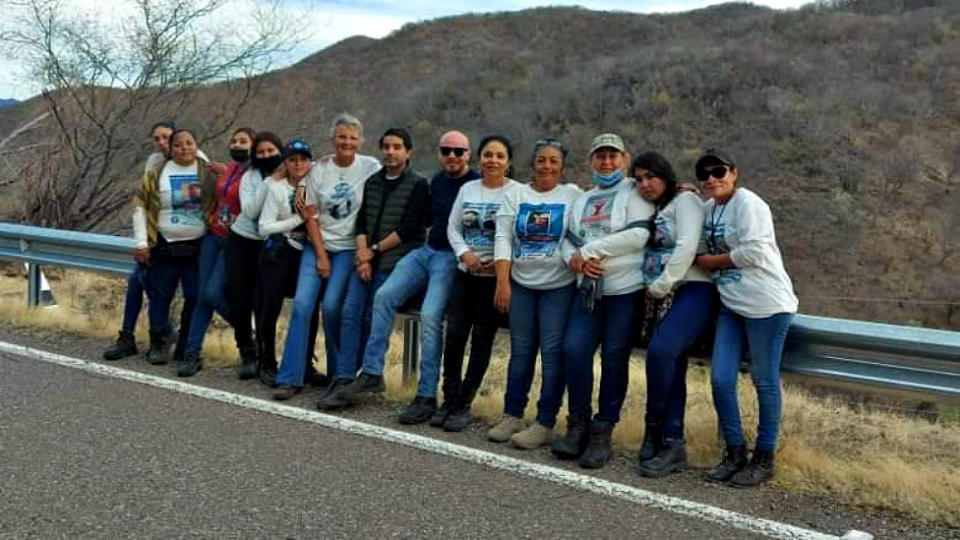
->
[0, 341, 872, 540]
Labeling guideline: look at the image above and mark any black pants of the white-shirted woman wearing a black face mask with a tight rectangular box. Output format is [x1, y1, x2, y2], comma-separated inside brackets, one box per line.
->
[224, 231, 263, 351]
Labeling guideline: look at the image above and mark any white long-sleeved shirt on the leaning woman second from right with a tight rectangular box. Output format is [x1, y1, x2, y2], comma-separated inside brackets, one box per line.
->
[643, 192, 710, 298]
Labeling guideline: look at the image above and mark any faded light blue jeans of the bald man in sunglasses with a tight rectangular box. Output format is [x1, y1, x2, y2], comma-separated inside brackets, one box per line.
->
[362, 245, 457, 398]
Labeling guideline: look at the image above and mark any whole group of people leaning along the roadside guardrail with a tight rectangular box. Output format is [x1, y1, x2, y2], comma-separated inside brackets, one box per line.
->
[104, 114, 797, 486]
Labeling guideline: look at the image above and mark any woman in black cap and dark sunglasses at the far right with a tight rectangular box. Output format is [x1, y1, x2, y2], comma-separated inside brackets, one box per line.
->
[694, 148, 797, 487]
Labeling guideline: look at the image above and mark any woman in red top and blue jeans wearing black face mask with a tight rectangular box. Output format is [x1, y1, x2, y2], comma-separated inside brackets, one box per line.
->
[177, 127, 257, 377]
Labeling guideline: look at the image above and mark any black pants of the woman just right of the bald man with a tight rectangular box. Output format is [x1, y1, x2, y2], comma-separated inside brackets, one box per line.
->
[443, 270, 508, 408]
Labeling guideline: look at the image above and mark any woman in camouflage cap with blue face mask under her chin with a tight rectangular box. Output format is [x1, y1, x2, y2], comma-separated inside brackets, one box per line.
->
[551, 133, 654, 469]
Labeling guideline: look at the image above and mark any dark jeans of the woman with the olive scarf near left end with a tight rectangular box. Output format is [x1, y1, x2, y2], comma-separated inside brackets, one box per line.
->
[147, 252, 197, 348]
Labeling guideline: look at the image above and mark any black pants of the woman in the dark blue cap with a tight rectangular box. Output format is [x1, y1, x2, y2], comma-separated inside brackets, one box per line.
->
[257, 237, 320, 374]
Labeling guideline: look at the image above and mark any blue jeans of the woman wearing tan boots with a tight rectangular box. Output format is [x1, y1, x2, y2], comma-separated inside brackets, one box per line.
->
[503, 282, 573, 428]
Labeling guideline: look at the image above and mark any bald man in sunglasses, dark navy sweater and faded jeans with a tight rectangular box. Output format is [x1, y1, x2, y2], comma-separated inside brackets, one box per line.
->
[317, 131, 480, 424]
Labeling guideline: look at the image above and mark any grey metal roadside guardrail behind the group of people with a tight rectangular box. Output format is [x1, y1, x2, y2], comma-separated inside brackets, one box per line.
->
[0, 223, 960, 398]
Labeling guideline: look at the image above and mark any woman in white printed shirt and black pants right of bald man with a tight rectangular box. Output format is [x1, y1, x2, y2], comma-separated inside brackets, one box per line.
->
[430, 135, 520, 431]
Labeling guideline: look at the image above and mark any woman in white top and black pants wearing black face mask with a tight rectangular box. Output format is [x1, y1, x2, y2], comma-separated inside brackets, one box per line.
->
[225, 131, 283, 379]
